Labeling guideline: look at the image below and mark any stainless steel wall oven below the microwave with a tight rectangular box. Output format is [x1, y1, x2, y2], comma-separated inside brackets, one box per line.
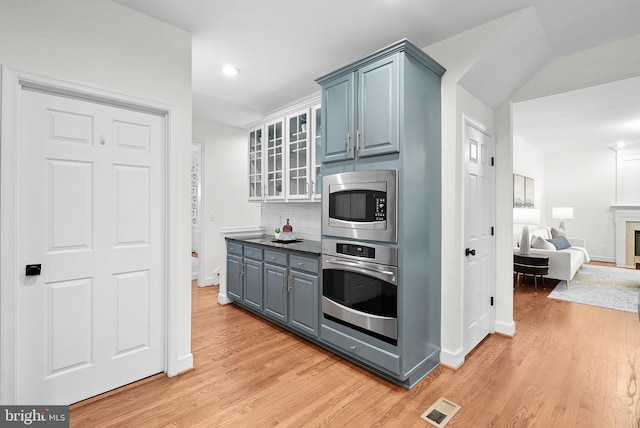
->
[322, 239, 398, 345]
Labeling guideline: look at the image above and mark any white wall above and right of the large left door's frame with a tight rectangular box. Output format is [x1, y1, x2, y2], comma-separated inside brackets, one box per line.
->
[0, 0, 193, 374]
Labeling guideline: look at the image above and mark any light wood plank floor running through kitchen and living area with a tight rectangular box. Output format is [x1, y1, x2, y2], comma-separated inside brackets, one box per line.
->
[70, 268, 640, 428]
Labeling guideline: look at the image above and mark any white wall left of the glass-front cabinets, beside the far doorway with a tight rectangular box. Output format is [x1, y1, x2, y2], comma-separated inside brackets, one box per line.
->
[193, 117, 260, 284]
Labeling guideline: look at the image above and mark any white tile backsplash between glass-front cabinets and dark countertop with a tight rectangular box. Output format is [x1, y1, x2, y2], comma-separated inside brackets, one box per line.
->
[262, 202, 322, 241]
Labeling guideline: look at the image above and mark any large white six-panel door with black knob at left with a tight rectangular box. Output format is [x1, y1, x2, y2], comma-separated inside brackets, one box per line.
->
[16, 89, 165, 404]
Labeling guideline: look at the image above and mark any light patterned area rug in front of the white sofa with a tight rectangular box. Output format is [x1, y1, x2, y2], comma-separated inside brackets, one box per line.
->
[548, 264, 640, 312]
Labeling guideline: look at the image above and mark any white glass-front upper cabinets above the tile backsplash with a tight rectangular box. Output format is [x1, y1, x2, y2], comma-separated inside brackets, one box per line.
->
[249, 101, 322, 201]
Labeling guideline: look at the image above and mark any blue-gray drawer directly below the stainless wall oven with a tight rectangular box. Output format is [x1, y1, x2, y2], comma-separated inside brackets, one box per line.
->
[321, 325, 400, 374]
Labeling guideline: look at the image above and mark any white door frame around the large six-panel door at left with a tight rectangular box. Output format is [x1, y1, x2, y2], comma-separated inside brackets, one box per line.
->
[0, 66, 180, 405]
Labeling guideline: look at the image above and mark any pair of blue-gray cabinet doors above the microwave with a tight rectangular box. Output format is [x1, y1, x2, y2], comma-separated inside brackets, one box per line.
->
[318, 53, 400, 162]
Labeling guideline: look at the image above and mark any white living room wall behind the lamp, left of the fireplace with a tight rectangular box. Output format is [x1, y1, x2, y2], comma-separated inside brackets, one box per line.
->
[545, 149, 616, 262]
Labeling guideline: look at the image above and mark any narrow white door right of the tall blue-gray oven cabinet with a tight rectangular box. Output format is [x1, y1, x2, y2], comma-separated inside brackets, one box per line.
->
[464, 119, 495, 355]
